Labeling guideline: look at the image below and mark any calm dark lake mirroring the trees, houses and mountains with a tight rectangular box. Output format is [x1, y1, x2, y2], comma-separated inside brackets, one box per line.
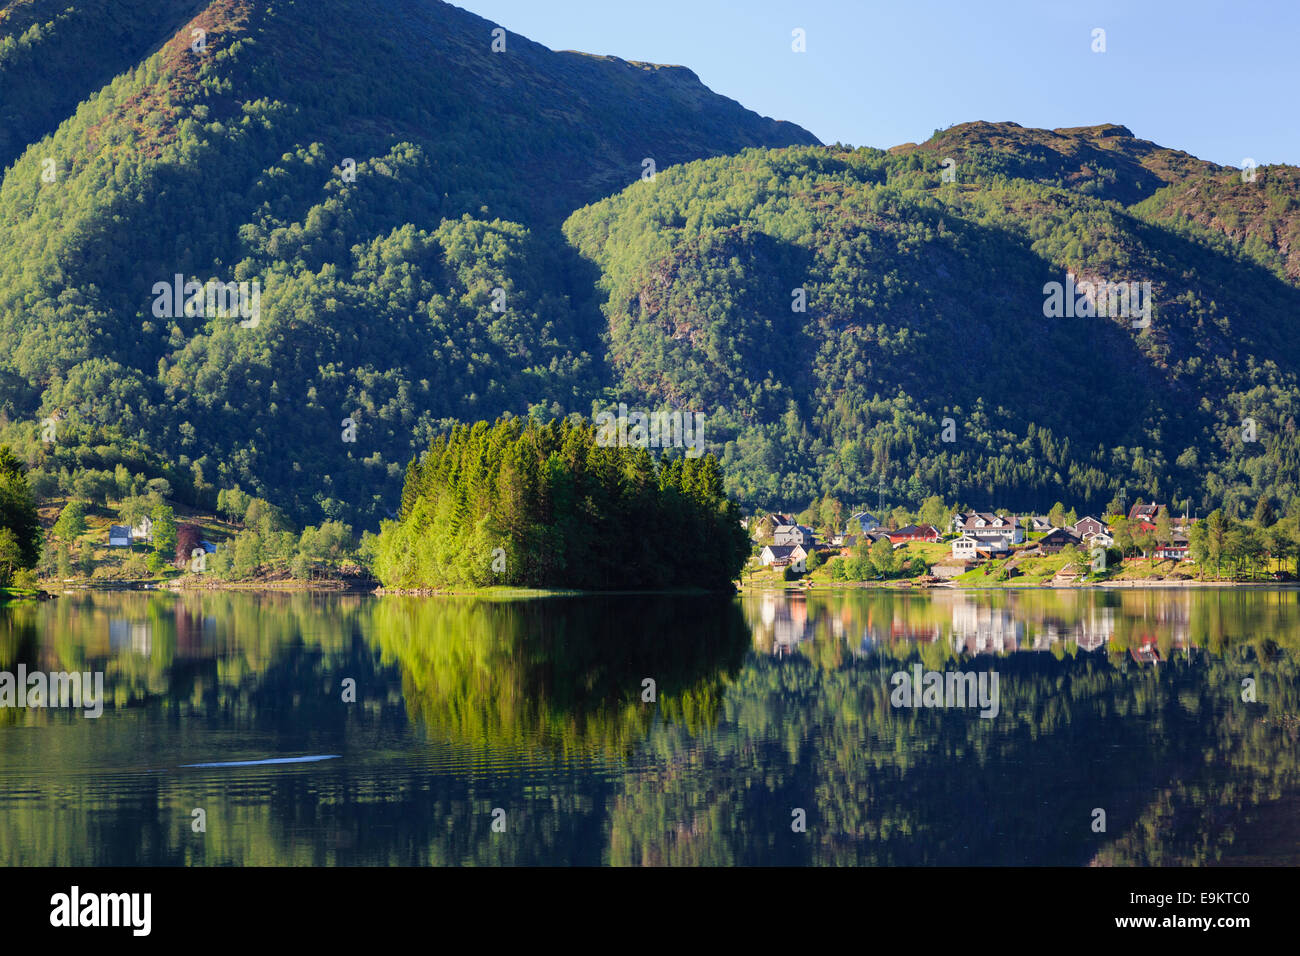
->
[0, 589, 1300, 866]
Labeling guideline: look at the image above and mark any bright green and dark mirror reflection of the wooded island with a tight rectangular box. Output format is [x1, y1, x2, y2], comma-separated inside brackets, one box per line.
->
[365, 596, 748, 754]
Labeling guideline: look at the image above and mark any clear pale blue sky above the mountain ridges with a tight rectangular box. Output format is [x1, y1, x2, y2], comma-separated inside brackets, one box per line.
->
[456, 0, 1300, 166]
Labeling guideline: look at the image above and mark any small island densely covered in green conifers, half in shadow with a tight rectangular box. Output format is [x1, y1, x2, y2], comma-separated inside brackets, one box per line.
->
[372, 418, 750, 591]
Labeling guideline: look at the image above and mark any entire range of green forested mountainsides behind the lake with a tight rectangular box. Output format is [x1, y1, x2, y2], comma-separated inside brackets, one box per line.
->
[0, 0, 1300, 528]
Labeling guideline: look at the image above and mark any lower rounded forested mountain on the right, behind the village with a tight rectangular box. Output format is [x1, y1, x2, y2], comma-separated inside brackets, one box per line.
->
[566, 122, 1300, 509]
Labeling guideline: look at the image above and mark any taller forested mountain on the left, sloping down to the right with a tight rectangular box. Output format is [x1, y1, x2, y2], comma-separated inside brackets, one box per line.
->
[0, 0, 818, 522]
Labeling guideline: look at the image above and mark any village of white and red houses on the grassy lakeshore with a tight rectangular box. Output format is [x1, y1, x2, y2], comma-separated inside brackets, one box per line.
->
[746, 501, 1195, 587]
